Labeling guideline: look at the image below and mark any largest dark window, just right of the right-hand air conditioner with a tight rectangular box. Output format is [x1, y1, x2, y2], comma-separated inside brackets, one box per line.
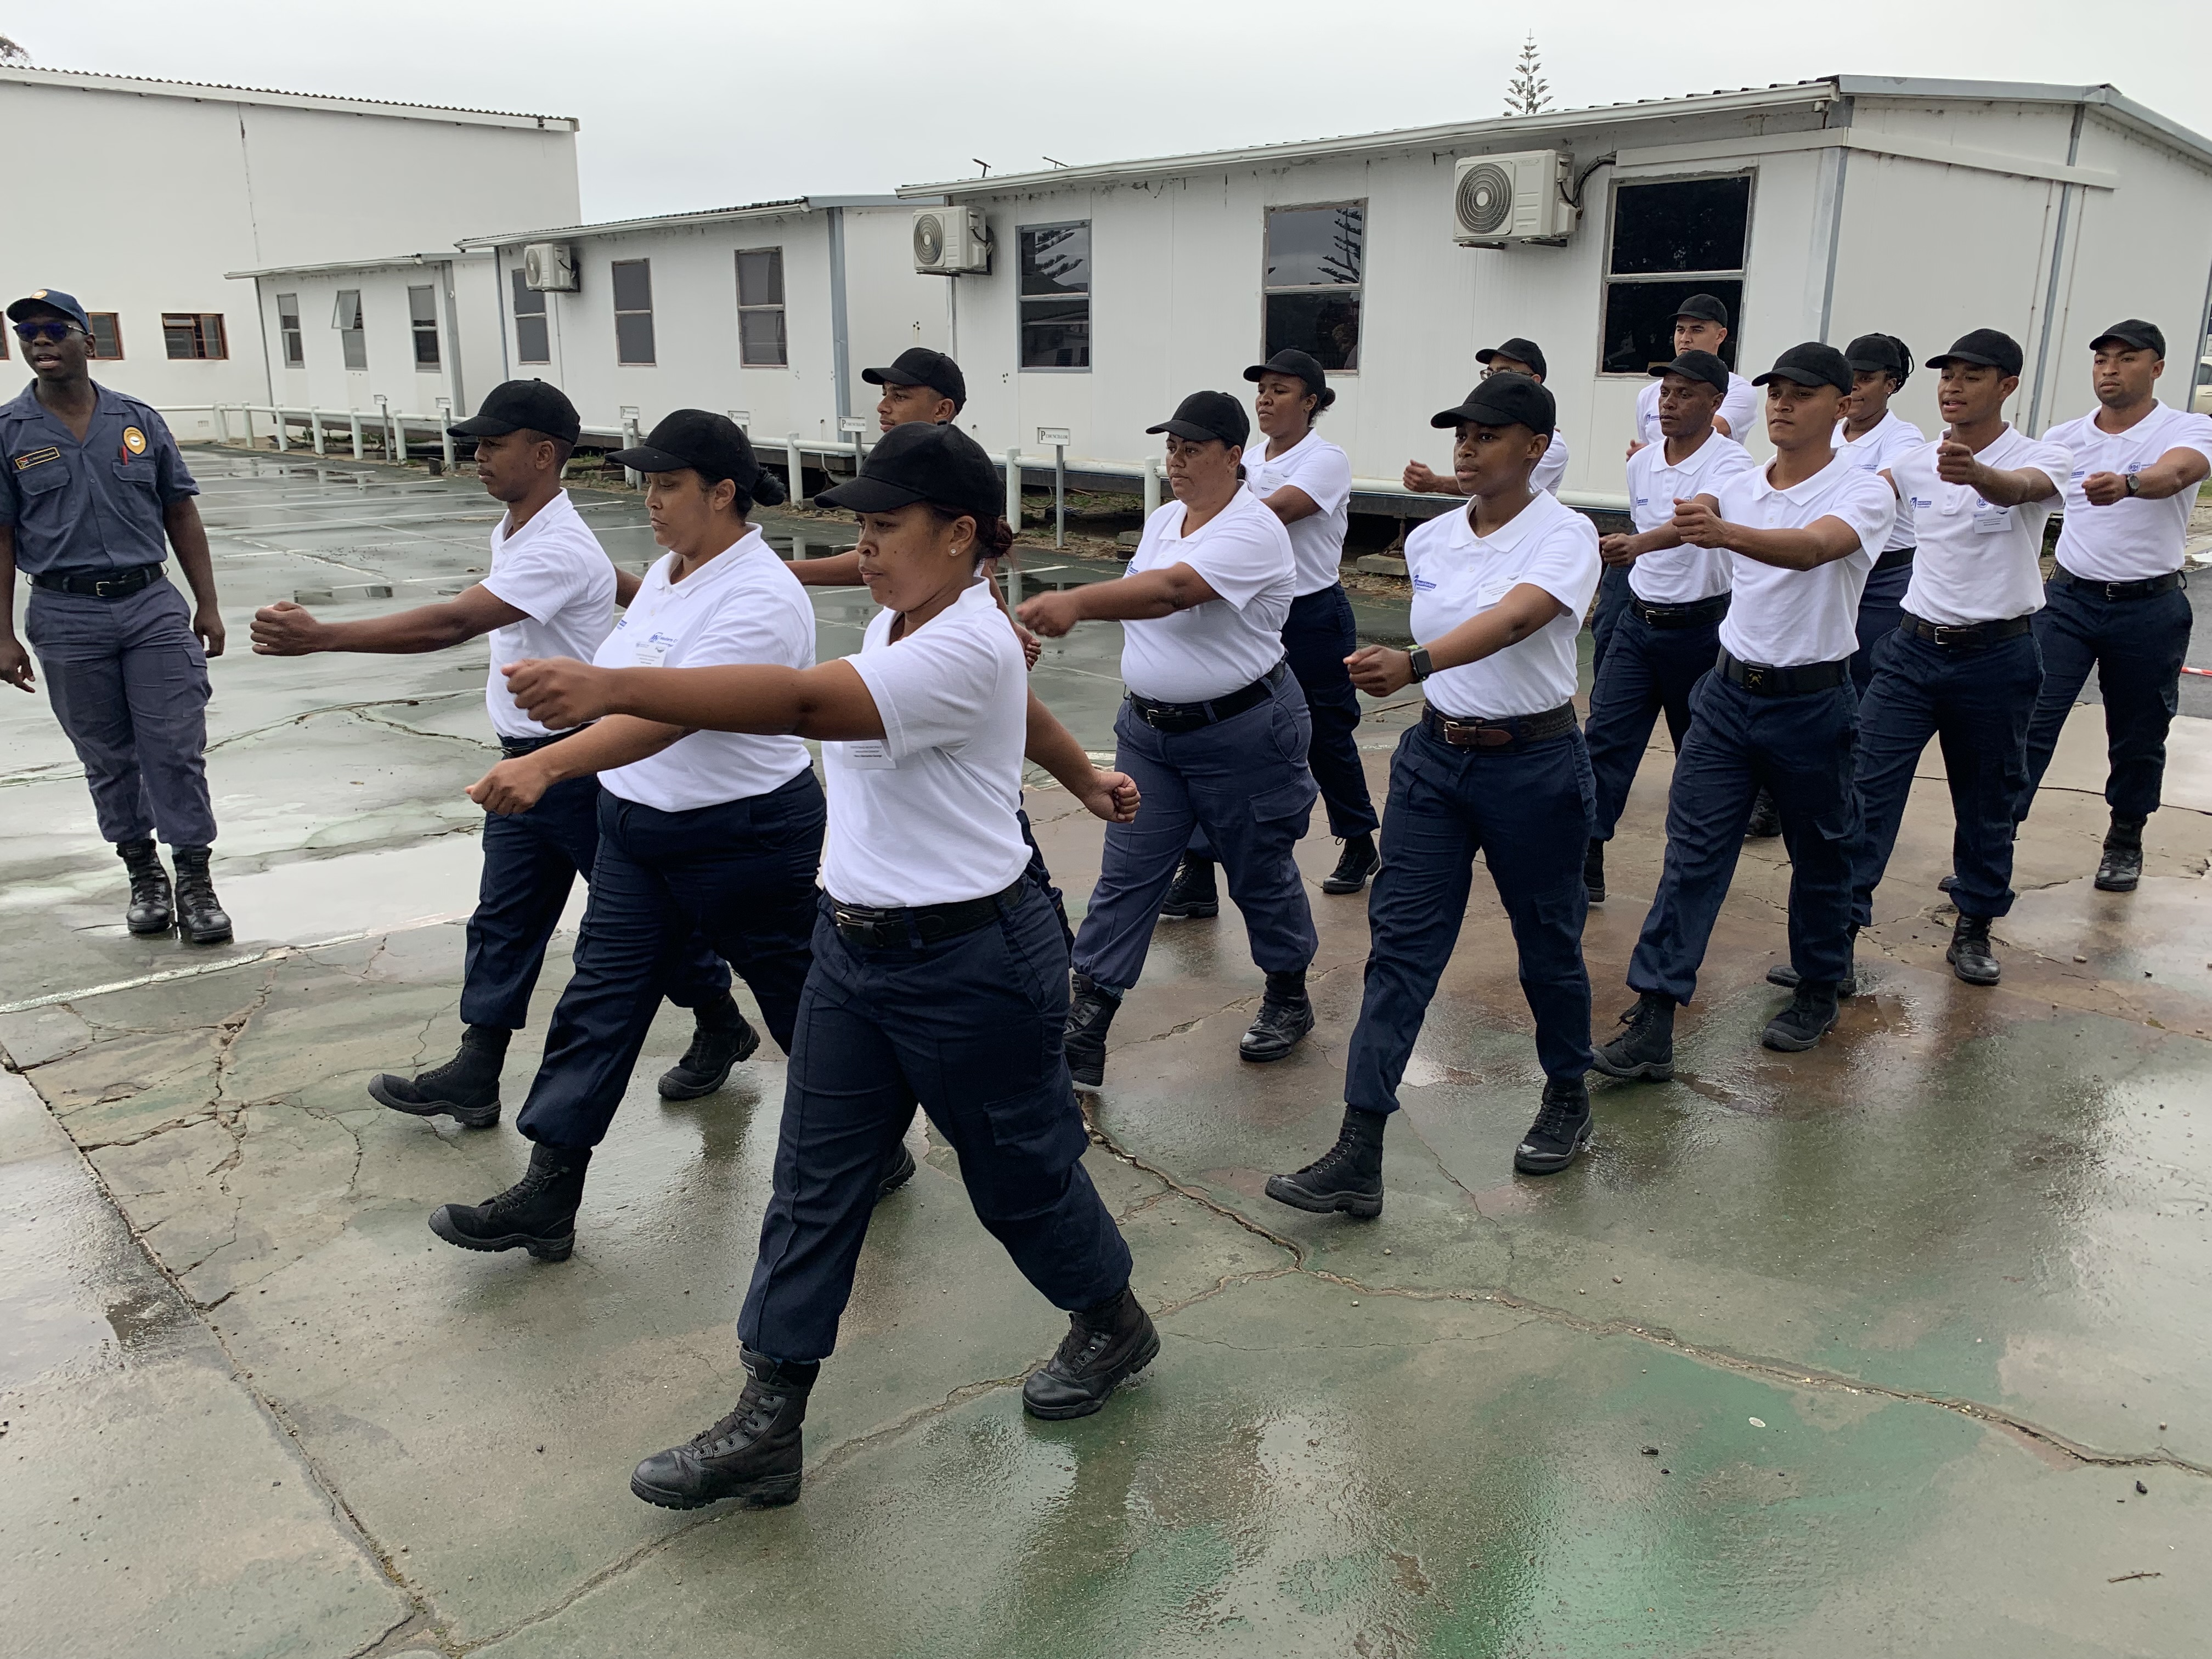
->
[1599, 172, 1752, 374]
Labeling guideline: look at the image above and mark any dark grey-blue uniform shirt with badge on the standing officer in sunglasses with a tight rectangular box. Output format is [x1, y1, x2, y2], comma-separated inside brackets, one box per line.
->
[0, 385, 199, 575]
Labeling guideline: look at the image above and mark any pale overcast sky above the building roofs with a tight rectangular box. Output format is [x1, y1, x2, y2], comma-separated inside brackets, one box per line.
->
[17, 0, 2212, 219]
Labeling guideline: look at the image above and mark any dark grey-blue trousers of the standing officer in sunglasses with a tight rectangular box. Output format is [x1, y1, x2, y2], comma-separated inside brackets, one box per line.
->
[24, 582, 215, 847]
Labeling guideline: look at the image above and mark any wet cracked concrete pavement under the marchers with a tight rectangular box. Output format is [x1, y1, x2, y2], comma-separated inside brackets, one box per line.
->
[0, 454, 2212, 1657]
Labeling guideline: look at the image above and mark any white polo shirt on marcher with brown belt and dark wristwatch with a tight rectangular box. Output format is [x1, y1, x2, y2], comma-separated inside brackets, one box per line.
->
[1404, 479, 1601, 721]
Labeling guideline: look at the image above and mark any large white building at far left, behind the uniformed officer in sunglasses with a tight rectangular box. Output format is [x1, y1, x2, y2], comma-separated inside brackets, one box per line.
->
[0, 66, 579, 438]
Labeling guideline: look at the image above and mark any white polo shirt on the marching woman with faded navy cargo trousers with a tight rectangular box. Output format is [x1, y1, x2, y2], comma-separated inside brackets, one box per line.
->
[1124, 489, 1296, 703]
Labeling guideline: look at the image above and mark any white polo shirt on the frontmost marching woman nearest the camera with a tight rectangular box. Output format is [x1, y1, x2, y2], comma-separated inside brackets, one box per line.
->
[827, 582, 1029, 907]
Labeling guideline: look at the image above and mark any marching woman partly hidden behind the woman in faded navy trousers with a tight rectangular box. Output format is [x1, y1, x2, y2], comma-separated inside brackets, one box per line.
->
[1159, 349, 1383, 916]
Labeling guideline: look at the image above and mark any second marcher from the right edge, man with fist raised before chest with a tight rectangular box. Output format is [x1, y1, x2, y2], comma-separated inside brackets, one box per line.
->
[1831, 328, 2073, 995]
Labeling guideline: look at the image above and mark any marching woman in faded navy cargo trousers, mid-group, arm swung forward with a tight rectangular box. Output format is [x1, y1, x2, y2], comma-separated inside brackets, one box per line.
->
[1020, 392, 1321, 1088]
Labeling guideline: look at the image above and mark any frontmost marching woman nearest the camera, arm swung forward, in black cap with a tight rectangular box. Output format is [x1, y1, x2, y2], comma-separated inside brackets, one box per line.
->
[493, 425, 1159, 1509]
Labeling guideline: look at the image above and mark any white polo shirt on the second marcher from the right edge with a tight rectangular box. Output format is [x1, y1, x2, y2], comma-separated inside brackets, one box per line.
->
[1889, 427, 2073, 626]
